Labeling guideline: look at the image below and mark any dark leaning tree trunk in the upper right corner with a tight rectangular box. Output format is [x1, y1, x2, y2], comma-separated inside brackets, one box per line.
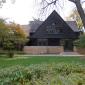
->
[69, 0, 85, 29]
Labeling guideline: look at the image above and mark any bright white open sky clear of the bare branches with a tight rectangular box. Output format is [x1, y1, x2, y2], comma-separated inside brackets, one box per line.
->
[0, 0, 84, 25]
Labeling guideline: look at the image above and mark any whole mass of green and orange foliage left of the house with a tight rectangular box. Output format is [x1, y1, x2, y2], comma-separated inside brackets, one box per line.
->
[0, 19, 27, 57]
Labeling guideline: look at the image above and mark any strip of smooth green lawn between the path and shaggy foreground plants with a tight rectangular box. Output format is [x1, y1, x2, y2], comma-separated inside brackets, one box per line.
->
[0, 56, 85, 68]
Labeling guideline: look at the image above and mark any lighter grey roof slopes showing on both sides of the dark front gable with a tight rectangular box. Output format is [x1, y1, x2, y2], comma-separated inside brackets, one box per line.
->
[22, 21, 79, 32]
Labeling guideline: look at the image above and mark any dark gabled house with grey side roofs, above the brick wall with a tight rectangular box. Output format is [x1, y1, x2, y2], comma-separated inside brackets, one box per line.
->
[27, 11, 79, 51]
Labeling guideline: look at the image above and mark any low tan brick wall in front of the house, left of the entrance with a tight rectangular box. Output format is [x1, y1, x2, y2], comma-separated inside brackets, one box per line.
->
[23, 46, 64, 54]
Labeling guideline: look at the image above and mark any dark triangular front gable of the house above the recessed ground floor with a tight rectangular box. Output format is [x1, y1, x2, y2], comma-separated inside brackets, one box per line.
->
[31, 10, 78, 38]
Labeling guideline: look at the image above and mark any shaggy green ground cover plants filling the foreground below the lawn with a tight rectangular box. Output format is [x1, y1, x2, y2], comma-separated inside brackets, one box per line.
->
[0, 63, 85, 85]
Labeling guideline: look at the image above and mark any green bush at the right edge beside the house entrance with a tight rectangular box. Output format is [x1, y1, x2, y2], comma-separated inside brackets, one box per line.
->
[74, 34, 85, 48]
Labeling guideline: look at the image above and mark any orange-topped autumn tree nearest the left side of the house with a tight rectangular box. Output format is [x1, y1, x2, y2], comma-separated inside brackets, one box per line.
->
[9, 23, 27, 50]
